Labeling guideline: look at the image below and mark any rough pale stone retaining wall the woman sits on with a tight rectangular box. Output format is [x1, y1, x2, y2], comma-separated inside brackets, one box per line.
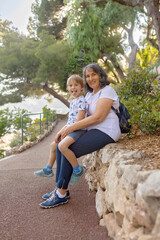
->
[83, 143, 160, 240]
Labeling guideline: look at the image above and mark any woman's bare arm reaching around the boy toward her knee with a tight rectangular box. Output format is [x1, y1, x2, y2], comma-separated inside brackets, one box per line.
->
[61, 98, 113, 138]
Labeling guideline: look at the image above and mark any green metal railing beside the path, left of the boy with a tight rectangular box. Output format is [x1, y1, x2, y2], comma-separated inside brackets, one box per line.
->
[21, 111, 57, 145]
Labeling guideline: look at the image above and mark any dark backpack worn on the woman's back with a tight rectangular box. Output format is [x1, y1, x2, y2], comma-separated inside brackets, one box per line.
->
[111, 102, 131, 133]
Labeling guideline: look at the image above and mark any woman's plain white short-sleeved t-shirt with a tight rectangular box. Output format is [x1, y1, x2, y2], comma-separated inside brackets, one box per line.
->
[85, 85, 121, 141]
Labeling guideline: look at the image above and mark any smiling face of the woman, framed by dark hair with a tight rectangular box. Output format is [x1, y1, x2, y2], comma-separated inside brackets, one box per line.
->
[86, 68, 100, 93]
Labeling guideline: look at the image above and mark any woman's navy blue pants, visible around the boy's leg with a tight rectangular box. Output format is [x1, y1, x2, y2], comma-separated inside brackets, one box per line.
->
[56, 129, 115, 189]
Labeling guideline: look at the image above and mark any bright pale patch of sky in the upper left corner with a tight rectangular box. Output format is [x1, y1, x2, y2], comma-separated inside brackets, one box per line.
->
[0, 0, 35, 35]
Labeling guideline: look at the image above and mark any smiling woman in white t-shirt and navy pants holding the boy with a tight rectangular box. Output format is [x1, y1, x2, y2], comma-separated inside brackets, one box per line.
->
[40, 64, 121, 208]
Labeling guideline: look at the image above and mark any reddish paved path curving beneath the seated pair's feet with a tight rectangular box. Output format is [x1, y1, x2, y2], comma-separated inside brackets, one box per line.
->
[0, 120, 109, 240]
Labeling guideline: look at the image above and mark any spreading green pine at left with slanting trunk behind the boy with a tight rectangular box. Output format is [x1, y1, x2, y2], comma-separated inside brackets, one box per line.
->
[0, 22, 70, 106]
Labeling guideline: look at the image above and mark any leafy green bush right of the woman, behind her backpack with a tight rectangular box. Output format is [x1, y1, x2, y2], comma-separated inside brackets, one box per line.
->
[117, 69, 160, 134]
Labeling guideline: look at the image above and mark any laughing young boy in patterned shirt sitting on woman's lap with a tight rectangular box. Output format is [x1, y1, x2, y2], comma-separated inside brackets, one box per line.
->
[34, 75, 88, 183]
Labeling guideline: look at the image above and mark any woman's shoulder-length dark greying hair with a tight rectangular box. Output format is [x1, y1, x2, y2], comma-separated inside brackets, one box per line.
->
[83, 63, 110, 92]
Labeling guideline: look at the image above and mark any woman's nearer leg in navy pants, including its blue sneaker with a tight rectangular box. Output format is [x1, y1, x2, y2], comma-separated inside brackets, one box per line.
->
[40, 129, 114, 208]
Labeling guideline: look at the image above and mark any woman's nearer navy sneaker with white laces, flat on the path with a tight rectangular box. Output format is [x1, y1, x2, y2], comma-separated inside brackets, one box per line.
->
[39, 192, 68, 208]
